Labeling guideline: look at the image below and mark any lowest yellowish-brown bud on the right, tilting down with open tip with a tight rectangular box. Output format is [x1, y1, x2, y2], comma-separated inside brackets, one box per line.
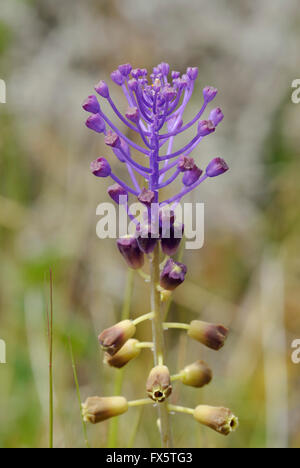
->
[194, 405, 239, 435]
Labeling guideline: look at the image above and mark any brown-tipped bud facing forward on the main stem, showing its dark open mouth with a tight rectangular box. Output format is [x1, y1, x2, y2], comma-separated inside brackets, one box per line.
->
[146, 366, 172, 403]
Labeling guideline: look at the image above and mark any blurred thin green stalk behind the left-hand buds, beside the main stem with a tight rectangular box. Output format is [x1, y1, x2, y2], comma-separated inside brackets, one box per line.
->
[108, 269, 134, 448]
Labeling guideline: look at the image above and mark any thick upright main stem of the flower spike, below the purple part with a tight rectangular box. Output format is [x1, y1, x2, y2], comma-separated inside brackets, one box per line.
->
[150, 244, 172, 448]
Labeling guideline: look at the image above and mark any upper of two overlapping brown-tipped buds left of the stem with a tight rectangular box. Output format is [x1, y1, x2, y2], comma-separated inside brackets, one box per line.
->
[98, 320, 136, 356]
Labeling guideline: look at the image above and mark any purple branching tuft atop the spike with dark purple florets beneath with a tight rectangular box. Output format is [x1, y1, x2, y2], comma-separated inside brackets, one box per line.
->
[84, 62, 228, 264]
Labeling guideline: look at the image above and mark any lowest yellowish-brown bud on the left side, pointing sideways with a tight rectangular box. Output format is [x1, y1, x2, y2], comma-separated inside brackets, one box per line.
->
[82, 397, 128, 424]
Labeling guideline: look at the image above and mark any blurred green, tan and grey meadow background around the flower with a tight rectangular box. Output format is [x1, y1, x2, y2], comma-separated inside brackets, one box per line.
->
[0, 0, 300, 447]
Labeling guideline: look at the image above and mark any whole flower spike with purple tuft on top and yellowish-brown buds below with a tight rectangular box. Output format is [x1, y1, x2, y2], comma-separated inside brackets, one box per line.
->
[83, 63, 237, 445]
